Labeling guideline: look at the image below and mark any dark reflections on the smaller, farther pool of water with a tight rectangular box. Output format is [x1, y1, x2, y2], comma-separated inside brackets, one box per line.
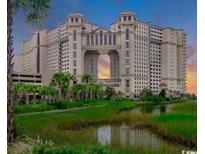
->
[130, 104, 172, 115]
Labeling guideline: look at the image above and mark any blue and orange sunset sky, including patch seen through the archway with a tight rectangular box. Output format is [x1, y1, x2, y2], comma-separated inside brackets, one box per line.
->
[14, 0, 197, 94]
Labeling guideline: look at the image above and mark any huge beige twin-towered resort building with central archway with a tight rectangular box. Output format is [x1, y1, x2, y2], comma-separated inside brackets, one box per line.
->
[15, 12, 186, 97]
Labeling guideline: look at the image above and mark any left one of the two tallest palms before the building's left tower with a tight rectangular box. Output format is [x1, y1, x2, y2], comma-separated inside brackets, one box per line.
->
[51, 72, 65, 100]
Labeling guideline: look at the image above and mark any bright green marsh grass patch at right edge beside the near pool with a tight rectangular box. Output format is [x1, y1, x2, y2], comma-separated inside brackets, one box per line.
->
[153, 102, 197, 147]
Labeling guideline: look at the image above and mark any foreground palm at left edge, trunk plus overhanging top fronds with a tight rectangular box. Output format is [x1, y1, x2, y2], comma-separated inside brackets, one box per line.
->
[7, 0, 50, 143]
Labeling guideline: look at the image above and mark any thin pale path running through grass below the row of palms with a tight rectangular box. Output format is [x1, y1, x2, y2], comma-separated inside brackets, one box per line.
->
[16, 104, 107, 116]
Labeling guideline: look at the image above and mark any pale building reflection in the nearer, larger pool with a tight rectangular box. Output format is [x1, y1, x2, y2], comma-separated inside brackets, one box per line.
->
[98, 125, 161, 150]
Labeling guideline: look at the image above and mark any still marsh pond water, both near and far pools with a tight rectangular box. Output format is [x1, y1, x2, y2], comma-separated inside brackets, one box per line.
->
[67, 104, 190, 153]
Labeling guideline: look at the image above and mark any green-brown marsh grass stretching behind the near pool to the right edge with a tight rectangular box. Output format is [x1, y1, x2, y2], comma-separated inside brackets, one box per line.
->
[15, 100, 196, 153]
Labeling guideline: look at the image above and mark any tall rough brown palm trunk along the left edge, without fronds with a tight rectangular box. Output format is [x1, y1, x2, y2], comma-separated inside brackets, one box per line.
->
[7, 0, 14, 143]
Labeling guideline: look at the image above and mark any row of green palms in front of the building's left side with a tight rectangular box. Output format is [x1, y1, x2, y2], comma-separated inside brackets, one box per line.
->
[12, 72, 103, 104]
